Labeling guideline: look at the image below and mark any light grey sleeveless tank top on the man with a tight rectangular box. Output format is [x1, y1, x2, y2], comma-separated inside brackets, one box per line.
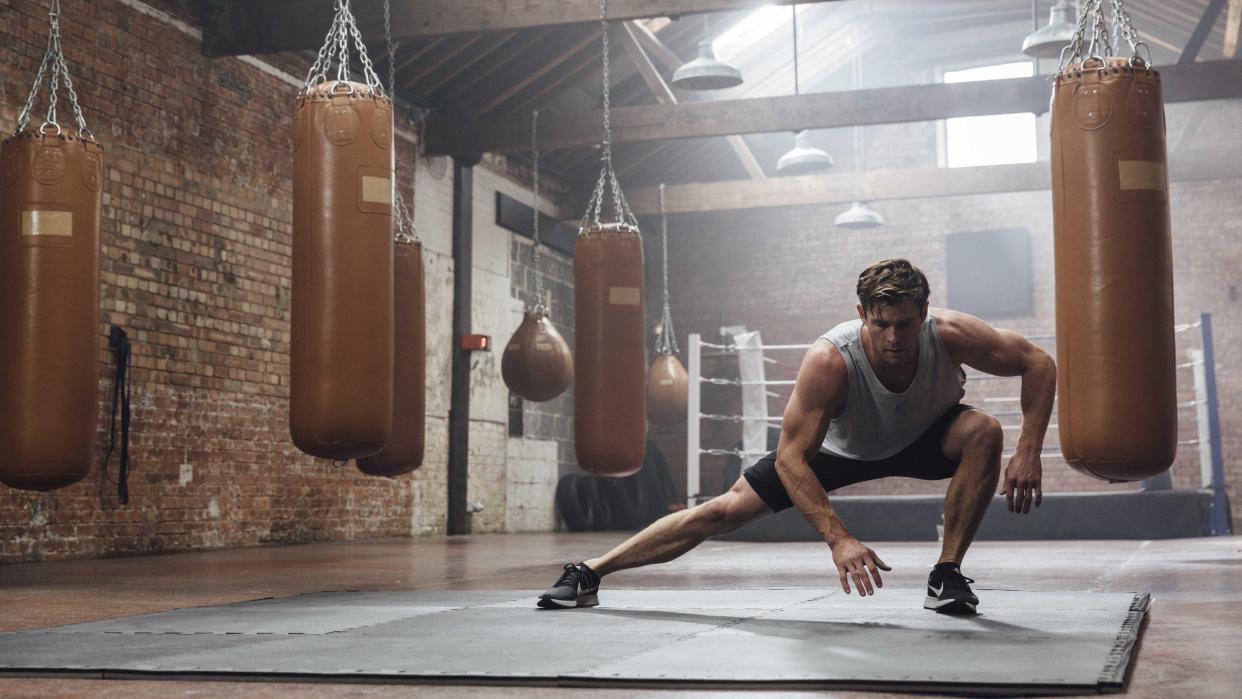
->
[820, 310, 966, 461]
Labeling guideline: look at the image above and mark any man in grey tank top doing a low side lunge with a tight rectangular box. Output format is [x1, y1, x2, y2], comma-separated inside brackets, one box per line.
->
[538, 259, 1057, 613]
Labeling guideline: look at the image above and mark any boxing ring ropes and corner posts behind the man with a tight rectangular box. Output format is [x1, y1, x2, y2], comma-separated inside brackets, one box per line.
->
[686, 313, 1228, 534]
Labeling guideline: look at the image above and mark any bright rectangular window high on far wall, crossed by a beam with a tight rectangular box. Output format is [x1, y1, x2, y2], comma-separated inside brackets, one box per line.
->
[944, 61, 1036, 168]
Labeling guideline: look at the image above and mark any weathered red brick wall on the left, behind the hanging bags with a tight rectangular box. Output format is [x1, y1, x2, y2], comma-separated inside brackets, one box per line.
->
[0, 0, 437, 562]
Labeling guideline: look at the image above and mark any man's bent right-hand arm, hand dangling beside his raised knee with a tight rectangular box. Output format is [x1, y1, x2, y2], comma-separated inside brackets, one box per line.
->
[936, 310, 1057, 514]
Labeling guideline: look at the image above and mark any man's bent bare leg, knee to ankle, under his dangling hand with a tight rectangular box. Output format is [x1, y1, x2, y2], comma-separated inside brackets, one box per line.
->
[936, 410, 1005, 565]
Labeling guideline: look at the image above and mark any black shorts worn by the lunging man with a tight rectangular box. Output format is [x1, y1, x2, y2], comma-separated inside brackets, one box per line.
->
[741, 404, 975, 512]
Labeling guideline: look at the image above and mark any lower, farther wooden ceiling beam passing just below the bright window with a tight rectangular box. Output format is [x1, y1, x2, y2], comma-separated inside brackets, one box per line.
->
[626, 150, 1242, 216]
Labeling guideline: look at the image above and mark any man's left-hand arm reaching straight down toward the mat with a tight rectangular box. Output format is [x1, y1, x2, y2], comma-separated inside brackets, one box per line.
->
[776, 340, 891, 596]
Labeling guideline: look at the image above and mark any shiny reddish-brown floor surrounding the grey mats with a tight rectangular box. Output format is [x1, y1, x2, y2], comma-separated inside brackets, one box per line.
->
[0, 534, 1242, 699]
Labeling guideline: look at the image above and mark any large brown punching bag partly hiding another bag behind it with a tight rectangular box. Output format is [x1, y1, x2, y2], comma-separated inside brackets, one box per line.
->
[289, 81, 394, 459]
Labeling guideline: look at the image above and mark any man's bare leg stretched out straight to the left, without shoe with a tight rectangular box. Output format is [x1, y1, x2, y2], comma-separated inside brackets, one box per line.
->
[584, 478, 771, 576]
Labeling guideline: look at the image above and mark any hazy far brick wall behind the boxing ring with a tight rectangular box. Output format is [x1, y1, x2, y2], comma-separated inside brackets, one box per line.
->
[668, 102, 1242, 518]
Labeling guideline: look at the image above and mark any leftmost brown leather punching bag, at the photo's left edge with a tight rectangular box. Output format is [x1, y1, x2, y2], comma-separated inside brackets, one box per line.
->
[0, 124, 103, 490]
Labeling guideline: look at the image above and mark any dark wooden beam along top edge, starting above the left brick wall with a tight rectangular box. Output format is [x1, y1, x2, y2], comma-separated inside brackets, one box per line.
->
[202, 0, 833, 56]
